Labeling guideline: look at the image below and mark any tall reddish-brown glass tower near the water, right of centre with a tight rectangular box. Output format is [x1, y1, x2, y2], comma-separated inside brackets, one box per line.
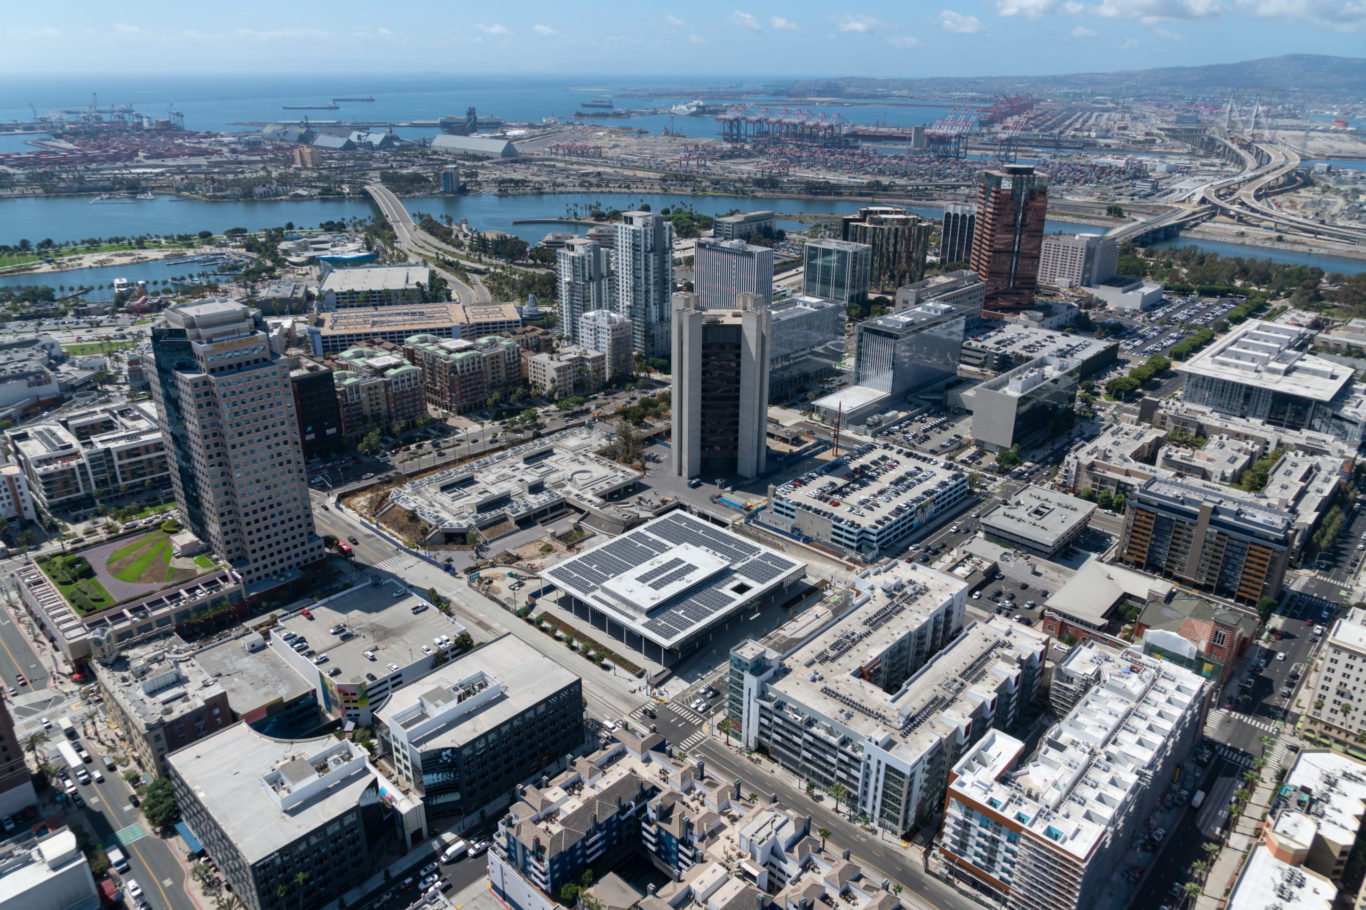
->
[971, 164, 1048, 313]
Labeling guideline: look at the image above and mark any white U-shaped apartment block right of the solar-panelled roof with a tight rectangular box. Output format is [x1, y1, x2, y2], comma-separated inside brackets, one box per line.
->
[727, 562, 1048, 833]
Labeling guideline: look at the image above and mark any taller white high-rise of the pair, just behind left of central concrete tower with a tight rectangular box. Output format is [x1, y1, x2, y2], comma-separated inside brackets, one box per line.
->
[611, 212, 673, 357]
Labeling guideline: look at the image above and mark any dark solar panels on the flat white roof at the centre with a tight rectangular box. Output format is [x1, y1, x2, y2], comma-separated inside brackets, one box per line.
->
[544, 512, 800, 641]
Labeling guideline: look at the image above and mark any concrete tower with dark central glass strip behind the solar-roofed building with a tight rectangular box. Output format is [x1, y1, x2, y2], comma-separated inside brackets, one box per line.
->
[672, 294, 772, 478]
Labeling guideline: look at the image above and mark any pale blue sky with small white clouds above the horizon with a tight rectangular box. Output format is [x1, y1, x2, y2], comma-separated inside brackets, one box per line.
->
[0, 0, 1366, 78]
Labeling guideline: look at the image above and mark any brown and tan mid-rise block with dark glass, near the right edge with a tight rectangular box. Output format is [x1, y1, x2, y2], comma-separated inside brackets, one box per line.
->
[1119, 477, 1295, 605]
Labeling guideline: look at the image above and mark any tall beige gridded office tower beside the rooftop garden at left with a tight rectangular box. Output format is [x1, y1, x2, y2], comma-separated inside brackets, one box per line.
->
[152, 299, 322, 593]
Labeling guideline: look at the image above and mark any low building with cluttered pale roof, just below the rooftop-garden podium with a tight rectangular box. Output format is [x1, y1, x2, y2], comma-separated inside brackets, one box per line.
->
[90, 634, 236, 777]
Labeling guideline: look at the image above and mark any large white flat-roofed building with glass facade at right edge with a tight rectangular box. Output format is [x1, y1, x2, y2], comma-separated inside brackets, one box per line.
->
[1176, 320, 1366, 444]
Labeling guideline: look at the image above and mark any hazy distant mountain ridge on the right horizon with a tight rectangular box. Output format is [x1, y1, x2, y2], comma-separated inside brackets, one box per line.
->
[791, 53, 1366, 98]
